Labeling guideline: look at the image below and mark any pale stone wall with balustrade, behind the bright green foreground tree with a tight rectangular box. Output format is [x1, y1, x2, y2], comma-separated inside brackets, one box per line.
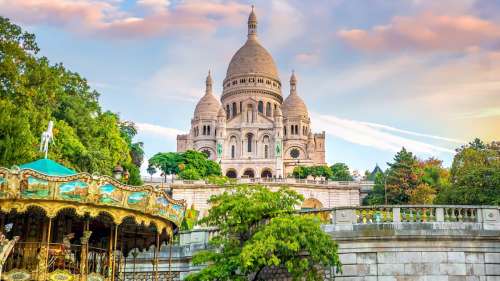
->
[127, 206, 500, 281]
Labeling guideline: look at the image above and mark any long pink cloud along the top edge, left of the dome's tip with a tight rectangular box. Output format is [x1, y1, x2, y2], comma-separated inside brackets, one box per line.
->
[0, 0, 249, 38]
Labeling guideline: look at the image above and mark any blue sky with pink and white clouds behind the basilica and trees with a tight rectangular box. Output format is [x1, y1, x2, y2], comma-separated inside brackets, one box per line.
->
[0, 0, 500, 173]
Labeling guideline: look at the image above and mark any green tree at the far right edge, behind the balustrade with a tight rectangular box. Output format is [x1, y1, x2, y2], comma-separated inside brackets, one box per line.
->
[436, 139, 500, 205]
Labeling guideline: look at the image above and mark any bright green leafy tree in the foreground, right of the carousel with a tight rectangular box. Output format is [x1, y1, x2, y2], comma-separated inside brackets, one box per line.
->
[186, 186, 340, 281]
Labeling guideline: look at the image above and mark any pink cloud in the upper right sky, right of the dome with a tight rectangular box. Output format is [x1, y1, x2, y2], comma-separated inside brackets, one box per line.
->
[338, 12, 500, 51]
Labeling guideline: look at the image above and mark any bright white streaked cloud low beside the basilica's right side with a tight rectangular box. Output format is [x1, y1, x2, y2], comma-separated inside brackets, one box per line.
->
[311, 113, 458, 156]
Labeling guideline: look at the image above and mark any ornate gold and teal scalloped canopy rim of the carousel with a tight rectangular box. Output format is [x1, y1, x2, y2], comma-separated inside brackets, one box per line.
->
[0, 165, 186, 231]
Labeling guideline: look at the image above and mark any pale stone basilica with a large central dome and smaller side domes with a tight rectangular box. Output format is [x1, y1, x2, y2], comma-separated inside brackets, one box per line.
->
[177, 9, 325, 178]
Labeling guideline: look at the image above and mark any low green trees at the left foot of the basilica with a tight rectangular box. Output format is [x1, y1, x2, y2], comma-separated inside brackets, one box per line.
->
[149, 150, 222, 180]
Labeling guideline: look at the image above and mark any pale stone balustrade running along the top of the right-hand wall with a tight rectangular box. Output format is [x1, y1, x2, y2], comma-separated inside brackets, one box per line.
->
[300, 205, 500, 225]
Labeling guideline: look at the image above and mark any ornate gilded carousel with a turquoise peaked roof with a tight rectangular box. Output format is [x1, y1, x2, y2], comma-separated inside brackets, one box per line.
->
[0, 155, 186, 281]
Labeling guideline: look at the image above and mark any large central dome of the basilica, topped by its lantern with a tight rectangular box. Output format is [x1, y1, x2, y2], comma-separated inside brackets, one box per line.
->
[226, 7, 279, 80]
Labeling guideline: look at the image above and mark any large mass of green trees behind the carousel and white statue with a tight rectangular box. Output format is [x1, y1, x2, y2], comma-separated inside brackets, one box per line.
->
[0, 17, 139, 175]
